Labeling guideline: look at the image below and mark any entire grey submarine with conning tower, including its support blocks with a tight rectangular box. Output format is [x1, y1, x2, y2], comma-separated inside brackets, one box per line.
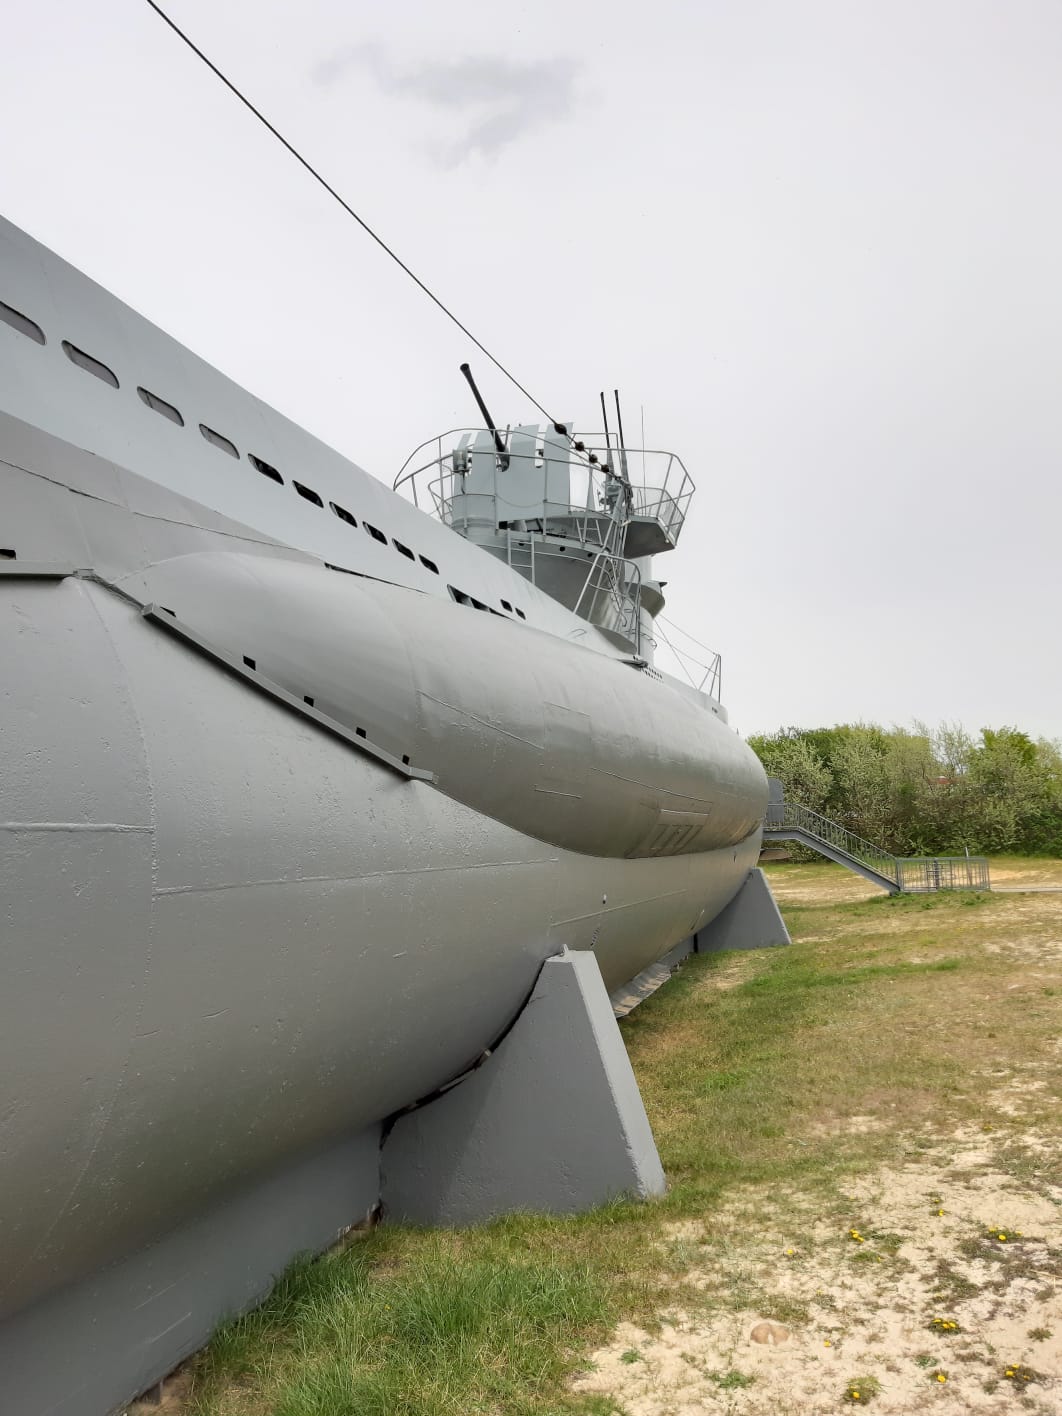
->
[0, 212, 783, 1416]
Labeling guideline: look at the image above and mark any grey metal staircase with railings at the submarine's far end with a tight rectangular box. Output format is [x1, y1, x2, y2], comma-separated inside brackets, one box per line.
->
[763, 777, 991, 895]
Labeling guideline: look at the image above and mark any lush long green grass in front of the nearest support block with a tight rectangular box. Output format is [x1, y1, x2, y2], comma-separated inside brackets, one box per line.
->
[189, 1228, 606, 1416]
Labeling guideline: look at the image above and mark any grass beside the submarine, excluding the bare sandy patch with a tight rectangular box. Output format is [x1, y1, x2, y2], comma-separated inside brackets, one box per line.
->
[188, 865, 1062, 1416]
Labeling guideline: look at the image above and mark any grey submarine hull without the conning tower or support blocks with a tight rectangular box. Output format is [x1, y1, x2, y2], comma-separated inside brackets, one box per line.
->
[0, 212, 766, 1416]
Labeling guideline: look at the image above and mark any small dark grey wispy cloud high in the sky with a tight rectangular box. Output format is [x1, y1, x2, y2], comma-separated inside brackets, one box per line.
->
[313, 44, 578, 166]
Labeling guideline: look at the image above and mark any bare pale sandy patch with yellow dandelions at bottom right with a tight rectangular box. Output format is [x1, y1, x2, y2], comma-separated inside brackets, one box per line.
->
[576, 1119, 1062, 1416]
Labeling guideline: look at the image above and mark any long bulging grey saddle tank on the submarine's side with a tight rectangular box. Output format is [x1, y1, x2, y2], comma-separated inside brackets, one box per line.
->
[128, 552, 762, 857]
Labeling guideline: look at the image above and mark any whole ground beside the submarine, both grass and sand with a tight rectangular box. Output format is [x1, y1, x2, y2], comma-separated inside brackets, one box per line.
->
[144, 858, 1062, 1416]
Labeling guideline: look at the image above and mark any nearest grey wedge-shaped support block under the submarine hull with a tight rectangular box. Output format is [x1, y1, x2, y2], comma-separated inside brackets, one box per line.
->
[381, 952, 664, 1225]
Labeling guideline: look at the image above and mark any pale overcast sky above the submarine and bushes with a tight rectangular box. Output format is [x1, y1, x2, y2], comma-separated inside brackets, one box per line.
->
[0, 0, 1062, 738]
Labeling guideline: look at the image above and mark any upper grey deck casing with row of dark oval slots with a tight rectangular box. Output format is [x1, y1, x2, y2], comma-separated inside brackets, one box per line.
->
[0, 217, 619, 657]
